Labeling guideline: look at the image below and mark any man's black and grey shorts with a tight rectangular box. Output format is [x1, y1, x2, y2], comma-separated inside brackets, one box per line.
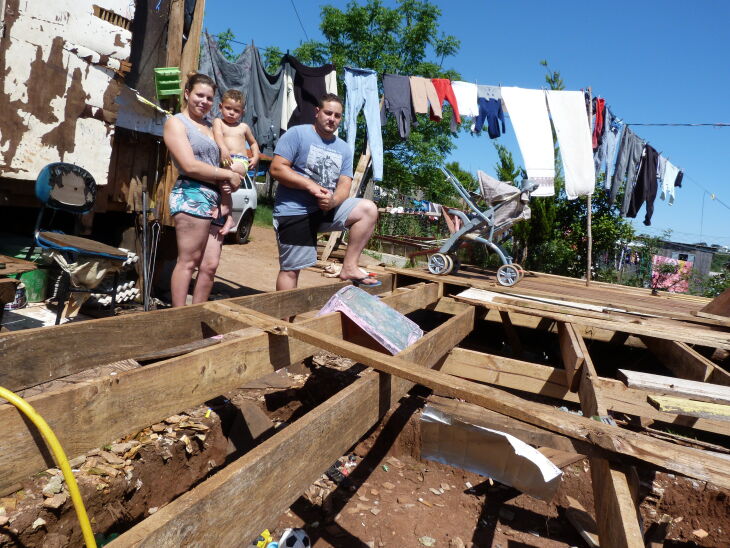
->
[274, 198, 360, 270]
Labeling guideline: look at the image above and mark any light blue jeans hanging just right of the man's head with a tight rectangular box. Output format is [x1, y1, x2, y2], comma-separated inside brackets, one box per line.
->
[345, 67, 383, 181]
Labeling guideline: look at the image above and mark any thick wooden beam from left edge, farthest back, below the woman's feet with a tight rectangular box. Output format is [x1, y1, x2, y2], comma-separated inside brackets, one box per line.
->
[0, 280, 393, 390]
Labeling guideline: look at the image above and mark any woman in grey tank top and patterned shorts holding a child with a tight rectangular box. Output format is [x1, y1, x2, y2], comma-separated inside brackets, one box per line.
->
[163, 73, 241, 306]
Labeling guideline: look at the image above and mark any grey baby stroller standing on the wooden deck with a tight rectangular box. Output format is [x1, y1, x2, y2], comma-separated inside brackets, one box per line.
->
[428, 166, 538, 287]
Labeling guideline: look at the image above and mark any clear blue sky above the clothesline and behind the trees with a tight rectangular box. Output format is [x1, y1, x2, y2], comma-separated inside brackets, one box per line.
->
[204, 0, 730, 246]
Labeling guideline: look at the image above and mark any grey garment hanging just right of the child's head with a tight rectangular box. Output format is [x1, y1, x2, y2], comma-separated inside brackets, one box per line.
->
[245, 48, 284, 155]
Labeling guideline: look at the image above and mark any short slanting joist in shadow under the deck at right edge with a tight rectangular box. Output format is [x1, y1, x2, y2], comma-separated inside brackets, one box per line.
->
[641, 336, 730, 386]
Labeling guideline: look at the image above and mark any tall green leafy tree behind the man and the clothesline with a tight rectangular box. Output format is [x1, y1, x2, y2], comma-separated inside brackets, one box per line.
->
[286, 0, 460, 203]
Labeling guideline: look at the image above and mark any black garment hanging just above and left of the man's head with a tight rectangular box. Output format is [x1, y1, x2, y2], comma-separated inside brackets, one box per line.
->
[281, 54, 337, 127]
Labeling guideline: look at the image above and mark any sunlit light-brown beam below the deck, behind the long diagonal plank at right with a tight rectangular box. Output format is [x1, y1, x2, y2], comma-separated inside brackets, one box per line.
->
[440, 348, 730, 436]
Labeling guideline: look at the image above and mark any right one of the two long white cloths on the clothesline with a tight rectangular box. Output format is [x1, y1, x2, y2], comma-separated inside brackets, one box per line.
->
[545, 90, 596, 200]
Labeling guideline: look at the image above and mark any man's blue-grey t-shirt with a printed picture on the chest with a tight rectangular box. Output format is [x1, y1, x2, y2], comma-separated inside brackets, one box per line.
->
[274, 124, 352, 216]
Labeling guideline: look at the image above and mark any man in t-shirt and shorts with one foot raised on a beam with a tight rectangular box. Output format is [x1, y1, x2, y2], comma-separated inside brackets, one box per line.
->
[270, 93, 381, 291]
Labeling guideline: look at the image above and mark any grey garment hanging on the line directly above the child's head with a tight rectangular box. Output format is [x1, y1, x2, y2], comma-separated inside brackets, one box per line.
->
[198, 32, 253, 120]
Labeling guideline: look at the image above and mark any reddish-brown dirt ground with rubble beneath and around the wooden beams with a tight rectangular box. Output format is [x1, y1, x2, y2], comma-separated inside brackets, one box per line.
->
[0, 227, 730, 548]
